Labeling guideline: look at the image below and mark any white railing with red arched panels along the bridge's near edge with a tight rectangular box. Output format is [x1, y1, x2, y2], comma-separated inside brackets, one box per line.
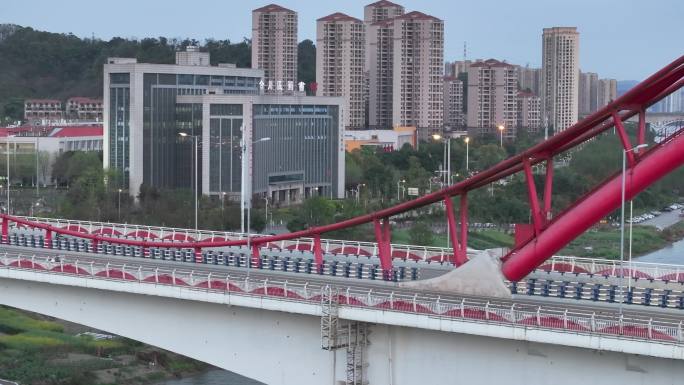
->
[0, 253, 684, 345]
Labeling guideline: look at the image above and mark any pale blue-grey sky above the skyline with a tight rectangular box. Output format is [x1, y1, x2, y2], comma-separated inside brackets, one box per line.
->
[0, 0, 684, 80]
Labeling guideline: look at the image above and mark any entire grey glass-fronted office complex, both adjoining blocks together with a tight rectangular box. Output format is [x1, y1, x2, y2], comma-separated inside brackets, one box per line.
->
[103, 55, 344, 204]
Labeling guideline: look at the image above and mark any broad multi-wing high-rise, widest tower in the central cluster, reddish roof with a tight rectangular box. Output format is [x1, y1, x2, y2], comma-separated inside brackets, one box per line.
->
[367, 11, 444, 137]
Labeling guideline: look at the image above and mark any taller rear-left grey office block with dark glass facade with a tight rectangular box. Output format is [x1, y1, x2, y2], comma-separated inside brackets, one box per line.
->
[104, 58, 263, 195]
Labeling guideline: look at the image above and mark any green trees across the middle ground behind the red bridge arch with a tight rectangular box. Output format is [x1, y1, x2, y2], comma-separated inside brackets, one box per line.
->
[13, 123, 684, 244]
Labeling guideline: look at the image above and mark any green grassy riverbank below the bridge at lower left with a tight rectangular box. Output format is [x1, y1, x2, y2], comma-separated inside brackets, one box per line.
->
[0, 307, 210, 385]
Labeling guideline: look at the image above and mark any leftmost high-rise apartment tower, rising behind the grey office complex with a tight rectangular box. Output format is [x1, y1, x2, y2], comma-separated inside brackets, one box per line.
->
[252, 4, 297, 89]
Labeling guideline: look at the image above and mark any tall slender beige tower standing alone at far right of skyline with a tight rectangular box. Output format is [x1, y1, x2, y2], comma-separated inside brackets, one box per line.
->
[541, 27, 579, 132]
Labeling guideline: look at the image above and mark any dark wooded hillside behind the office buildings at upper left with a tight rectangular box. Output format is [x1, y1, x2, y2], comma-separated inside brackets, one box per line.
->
[0, 24, 316, 121]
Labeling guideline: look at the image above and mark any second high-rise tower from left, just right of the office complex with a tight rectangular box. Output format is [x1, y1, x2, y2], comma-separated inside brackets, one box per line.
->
[316, 12, 365, 129]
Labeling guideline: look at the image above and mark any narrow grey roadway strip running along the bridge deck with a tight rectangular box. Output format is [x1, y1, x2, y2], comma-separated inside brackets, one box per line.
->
[5, 245, 684, 323]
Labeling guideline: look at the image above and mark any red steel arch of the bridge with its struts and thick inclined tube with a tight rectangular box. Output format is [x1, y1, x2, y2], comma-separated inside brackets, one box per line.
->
[1, 56, 684, 281]
